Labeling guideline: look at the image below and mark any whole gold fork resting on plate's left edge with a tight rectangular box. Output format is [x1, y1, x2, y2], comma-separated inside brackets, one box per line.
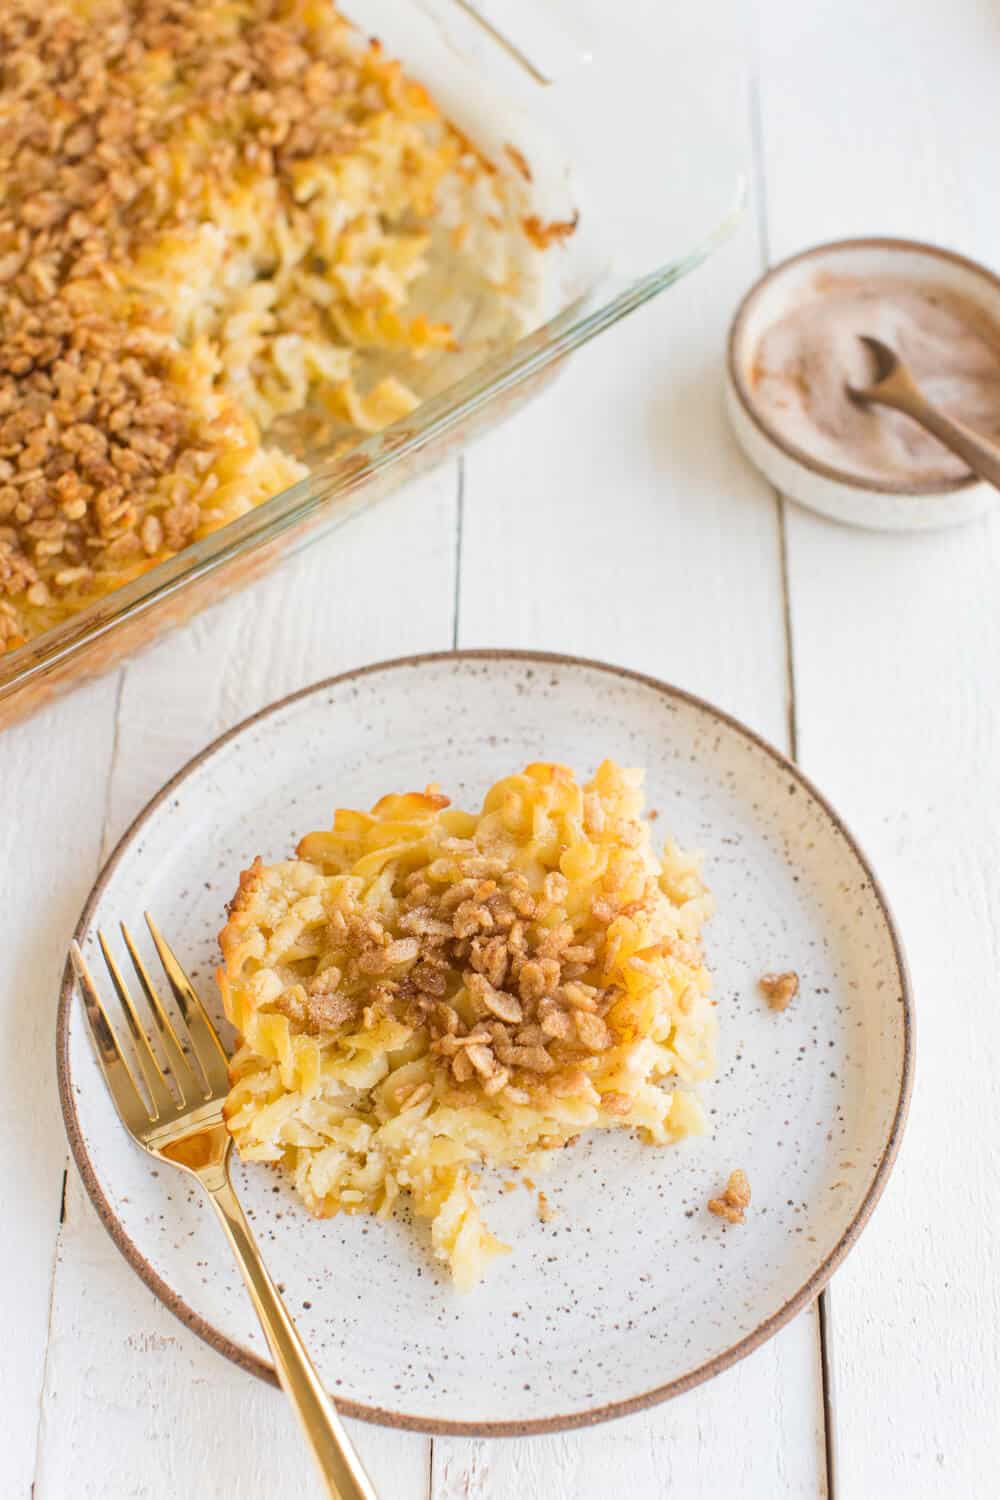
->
[70, 912, 378, 1500]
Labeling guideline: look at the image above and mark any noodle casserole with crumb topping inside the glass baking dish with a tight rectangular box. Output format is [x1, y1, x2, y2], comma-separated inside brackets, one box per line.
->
[0, 0, 548, 651]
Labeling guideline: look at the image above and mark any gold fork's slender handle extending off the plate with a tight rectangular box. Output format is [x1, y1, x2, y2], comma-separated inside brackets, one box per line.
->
[201, 1173, 378, 1500]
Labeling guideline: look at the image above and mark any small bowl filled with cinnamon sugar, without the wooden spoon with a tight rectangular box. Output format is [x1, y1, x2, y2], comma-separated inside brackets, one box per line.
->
[726, 239, 1000, 531]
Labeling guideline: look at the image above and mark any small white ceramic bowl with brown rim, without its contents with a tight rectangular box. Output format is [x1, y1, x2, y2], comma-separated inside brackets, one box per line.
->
[726, 240, 1000, 531]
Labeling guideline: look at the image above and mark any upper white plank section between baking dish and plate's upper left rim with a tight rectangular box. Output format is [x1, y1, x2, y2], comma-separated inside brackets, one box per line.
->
[100, 464, 457, 837]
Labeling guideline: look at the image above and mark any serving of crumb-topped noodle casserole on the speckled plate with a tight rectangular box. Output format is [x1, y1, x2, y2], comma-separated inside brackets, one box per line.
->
[219, 761, 715, 1286]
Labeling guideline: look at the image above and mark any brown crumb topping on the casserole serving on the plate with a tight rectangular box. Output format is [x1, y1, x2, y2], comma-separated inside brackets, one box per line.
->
[265, 800, 697, 1115]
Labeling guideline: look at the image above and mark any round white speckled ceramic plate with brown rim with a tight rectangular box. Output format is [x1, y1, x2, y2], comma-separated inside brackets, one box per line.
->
[58, 653, 912, 1433]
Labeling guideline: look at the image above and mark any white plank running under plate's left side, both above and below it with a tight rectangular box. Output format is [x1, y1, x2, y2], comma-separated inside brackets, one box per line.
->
[34, 464, 457, 1500]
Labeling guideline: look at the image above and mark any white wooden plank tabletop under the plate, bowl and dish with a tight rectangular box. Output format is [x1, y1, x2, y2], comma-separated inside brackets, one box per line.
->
[0, 0, 1000, 1500]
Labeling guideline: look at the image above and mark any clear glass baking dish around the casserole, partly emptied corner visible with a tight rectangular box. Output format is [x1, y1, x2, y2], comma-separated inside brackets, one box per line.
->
[0, 0, 744, 726]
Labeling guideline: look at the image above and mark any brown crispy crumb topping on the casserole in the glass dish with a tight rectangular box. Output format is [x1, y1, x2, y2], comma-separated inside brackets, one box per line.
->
[0, 0, 384, 645]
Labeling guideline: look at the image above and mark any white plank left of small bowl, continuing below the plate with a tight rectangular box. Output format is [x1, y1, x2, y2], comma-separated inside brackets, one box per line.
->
[432, 172, 823, 1500]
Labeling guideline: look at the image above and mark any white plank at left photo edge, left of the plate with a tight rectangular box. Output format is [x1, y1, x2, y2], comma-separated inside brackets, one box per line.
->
[0, 677, 117, 1497]
